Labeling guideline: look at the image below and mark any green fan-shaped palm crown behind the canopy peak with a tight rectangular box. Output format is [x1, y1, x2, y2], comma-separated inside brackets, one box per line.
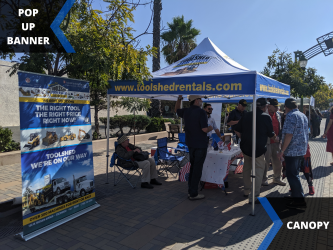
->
[161, 16, 200, 64]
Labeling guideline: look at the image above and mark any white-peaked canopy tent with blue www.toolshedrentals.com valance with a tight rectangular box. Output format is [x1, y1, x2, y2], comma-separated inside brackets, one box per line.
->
[106, 38, 290, 215]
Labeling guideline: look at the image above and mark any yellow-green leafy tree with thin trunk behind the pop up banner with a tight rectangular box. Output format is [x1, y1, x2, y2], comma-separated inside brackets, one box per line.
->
[65, 0, 155, 132]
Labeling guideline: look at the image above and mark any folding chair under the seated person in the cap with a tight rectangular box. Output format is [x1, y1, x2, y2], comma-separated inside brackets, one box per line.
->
[110, 142, 142, 188]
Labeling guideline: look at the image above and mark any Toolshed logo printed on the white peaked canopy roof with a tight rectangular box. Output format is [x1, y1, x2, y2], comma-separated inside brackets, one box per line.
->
[163, 54, 215, 76]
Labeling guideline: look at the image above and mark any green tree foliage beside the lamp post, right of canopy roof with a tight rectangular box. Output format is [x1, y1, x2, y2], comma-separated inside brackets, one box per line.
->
[261, 49, 325, 97]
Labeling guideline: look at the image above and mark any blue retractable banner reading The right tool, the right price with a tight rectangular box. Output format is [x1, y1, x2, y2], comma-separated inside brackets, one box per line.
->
[18, 72, 99, 240]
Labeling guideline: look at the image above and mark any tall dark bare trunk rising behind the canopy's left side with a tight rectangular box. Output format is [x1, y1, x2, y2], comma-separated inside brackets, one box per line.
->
[151, 0, 162, 117]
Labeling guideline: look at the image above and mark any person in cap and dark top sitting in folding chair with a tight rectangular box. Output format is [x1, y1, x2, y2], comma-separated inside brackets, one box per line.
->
[116, 135, 162, 189]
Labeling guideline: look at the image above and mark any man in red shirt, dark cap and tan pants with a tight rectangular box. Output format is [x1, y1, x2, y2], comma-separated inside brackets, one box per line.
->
[262, 99, 286, 186]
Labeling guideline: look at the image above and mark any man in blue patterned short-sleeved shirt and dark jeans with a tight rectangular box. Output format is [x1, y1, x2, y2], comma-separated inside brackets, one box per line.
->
[278, 98, 309, 208]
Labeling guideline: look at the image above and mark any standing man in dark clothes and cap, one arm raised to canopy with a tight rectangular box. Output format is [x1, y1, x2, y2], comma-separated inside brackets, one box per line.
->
[175, 95, 213, 200]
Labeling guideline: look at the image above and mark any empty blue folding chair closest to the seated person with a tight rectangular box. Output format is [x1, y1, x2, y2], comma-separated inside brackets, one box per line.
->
[154, 137, 185, 177]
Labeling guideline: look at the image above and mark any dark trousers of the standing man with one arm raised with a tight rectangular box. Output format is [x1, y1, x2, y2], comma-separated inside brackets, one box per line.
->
[188, 147, 207, 197]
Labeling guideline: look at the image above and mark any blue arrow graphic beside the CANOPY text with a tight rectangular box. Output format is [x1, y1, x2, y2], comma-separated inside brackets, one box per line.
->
[258, 197, 283, 250]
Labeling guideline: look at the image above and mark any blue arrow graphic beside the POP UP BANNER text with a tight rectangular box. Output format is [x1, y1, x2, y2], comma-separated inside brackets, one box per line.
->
[51, 0, 76, 53]
